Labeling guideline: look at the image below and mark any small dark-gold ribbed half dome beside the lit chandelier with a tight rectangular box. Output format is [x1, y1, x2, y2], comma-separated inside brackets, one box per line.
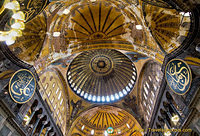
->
[8, 14, 47, 64]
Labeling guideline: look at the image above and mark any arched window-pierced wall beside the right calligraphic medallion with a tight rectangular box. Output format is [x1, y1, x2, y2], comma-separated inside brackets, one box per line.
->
[139, 60, 163, 122]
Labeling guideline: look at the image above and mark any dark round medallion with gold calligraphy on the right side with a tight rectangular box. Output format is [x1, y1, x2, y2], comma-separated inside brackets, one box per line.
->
[165, 59, 192, 95]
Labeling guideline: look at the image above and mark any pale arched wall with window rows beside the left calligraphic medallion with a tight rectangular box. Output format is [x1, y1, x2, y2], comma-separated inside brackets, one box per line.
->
[39, 68, 70, 134]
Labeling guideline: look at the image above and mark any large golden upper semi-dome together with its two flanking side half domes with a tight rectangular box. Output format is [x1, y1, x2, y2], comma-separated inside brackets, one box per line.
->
[2, 0, 191, 66]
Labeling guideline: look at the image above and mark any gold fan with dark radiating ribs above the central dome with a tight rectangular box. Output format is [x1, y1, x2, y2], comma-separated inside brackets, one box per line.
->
[63, 2, 129, 40]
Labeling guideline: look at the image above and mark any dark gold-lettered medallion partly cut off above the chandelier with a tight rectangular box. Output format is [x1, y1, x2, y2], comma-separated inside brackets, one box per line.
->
[18, 0, 49, 23]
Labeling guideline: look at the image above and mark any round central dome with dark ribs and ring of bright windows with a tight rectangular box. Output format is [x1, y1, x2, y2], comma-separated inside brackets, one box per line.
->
[67, 49, 137, 103]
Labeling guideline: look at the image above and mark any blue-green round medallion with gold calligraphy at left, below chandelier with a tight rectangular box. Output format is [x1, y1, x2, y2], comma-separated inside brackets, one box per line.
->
[9, 69, 36, 104]
